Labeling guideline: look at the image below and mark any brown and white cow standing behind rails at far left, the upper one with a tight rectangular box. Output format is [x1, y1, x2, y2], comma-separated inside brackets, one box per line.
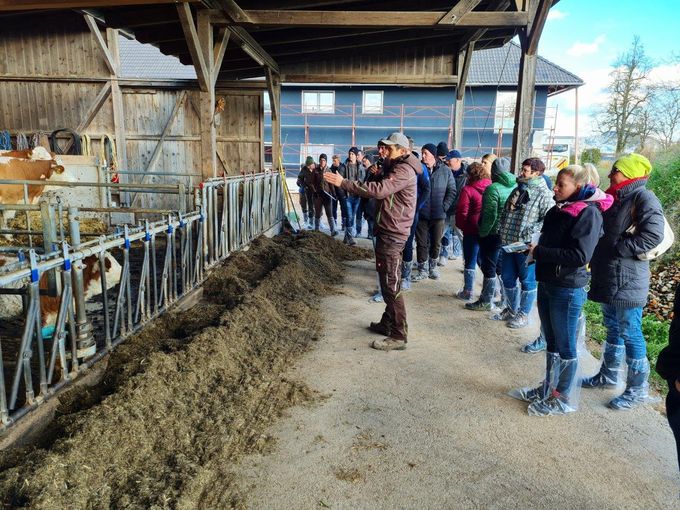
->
[0, 147, 64, 236]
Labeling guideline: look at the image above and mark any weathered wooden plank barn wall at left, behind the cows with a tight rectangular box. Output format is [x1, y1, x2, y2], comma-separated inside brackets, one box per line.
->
[0, 14, 264, 208]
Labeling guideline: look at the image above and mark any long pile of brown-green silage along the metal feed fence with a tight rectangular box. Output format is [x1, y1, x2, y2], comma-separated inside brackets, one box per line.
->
[0, 234, 368, 509]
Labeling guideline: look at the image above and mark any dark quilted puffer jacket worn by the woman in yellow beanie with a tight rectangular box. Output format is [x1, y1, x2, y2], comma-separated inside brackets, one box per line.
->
[588, 179, 664, 308]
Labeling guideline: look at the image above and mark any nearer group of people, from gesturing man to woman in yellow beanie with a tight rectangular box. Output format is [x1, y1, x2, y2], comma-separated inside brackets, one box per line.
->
[316, 133, 664, 416]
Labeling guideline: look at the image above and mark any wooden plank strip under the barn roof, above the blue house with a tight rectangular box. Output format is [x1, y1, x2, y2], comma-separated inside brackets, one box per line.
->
[281, 46, 455, 77]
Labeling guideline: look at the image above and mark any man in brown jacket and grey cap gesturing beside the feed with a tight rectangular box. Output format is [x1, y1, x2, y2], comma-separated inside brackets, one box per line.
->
[323, 133, 422, 351]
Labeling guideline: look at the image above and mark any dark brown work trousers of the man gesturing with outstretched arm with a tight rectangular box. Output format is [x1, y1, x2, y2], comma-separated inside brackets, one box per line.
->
[375, 234, 408, 341]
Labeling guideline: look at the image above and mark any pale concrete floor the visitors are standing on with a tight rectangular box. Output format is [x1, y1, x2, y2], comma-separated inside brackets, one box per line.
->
[237, 239, 680, 510]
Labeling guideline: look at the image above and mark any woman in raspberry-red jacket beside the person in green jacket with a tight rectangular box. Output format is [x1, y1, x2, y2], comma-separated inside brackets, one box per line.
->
[456, 163, 491, 301]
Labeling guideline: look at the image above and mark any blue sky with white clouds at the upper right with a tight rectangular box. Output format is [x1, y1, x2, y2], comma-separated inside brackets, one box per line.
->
[538, 0, 680, 135]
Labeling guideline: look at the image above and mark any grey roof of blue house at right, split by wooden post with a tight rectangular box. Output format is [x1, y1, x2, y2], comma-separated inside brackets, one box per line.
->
[467, 42, 583, 87]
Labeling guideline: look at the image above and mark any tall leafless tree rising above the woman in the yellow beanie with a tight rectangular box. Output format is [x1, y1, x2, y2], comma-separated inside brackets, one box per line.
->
[596, 36, 653, 155]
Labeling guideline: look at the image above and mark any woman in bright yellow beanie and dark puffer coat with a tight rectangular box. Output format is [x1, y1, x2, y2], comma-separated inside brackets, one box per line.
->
[582, 154, 664, 409]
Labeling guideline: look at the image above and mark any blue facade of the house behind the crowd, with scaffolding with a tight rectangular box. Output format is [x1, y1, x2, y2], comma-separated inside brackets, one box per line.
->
[265, 86, 548, 169]
